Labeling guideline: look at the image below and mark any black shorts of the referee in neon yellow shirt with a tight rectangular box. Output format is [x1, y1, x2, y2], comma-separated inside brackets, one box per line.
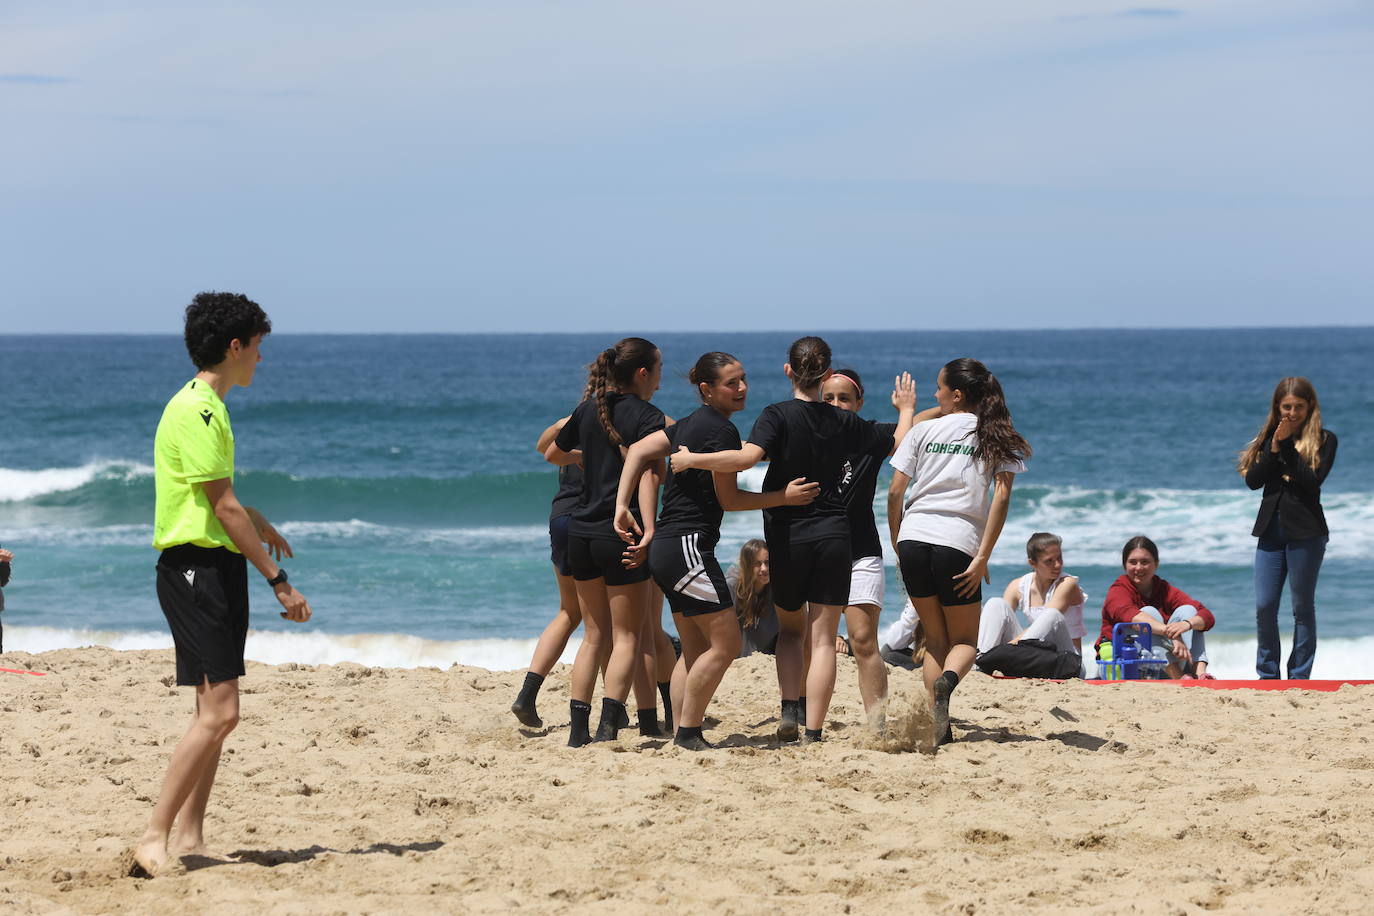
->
[158, 544, 249, 687]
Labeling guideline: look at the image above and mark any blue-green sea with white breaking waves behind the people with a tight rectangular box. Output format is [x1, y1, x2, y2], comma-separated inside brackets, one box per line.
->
[0, 328, 1374, 677]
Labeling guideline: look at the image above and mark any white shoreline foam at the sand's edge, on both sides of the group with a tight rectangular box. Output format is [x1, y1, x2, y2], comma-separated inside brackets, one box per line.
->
[4, 626, 1374, 680]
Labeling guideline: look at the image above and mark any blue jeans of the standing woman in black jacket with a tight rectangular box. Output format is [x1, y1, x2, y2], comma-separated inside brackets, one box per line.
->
[1254, 525, 1327, 680]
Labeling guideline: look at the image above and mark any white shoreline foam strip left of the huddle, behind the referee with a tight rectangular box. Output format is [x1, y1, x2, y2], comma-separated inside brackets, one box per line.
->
[4, 626, 581, 672]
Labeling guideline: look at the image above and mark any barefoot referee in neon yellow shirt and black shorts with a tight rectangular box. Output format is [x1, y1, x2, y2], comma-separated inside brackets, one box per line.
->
[135, 293, 311, 876]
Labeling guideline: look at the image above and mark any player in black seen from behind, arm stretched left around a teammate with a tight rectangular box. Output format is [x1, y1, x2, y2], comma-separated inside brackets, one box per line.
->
[672, 336, 892, 742]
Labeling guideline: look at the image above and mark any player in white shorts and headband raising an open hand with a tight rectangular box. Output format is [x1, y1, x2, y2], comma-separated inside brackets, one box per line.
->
[820, 369, 938, 717]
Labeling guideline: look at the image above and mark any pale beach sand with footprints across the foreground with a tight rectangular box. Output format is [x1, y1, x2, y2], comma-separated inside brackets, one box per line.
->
[0, 648, 1374, 913]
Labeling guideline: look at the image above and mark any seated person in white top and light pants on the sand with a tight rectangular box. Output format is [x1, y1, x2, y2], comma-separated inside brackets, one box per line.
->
[978, 531, 1088, 655]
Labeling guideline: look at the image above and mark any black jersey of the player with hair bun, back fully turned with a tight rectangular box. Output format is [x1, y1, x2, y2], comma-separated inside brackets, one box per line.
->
[749, 398, 892, 544]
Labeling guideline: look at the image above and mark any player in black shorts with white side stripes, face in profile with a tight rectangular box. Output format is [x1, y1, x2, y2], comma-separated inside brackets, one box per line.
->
[616, 353, 820, 750]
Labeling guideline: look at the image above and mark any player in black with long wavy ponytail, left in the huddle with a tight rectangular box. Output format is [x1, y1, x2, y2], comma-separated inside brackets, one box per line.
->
[544, 338, 664, 747]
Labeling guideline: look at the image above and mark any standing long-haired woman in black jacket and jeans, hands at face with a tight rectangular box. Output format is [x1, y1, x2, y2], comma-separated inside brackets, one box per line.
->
[1238, 376, 1336, 680]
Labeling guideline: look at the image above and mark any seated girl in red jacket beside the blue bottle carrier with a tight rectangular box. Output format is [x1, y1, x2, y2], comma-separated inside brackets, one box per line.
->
[1096, 536, 1216, 680]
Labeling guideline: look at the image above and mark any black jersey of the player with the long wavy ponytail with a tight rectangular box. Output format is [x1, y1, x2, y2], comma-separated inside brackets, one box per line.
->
[554, 393, 664, 541]
